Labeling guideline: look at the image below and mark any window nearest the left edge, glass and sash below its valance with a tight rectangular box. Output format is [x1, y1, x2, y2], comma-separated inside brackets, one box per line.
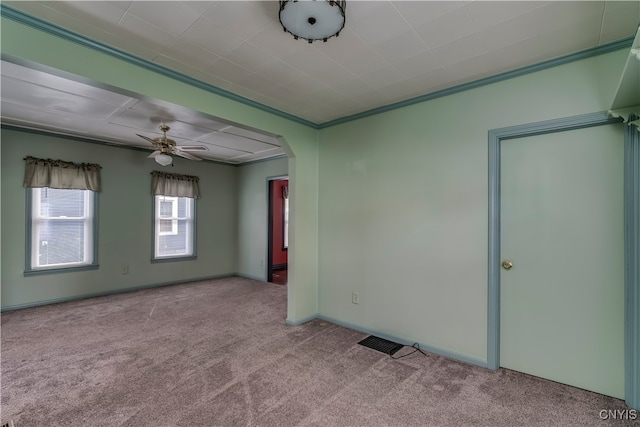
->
[25, 187, 97, 273]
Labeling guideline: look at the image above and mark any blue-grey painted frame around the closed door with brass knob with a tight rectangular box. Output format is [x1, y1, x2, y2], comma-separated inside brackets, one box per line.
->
[487, 112, 640, 409]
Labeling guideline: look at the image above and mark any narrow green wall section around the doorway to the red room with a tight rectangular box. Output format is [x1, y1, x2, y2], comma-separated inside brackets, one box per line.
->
[237, 158, 289, 280]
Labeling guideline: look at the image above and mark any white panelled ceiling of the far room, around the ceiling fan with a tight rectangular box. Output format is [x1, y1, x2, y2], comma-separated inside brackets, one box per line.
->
[1, 61, 285, 164]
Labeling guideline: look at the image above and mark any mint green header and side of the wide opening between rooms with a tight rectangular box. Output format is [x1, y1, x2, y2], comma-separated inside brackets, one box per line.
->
[0, 18, 318, 321]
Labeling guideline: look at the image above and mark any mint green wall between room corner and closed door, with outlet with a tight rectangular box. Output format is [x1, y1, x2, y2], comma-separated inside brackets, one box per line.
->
[318, 51, 627, 360]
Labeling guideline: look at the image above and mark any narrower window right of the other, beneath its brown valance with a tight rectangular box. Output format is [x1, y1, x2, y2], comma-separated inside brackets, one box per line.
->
[153, 195, 195, 260]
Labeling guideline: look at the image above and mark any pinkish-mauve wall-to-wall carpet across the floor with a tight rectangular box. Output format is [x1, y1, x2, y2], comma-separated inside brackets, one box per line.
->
[1, 278, 640, 427]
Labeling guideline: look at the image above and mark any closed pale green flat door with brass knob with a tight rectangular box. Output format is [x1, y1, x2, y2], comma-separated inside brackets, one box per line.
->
[500, 125, 624, 398]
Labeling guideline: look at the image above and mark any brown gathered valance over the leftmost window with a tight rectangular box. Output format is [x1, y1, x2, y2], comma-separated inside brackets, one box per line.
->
[23, 156, 101, 192]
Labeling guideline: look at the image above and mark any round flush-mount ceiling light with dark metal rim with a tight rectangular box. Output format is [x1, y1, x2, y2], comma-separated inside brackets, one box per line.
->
[280, 0, 347, 43]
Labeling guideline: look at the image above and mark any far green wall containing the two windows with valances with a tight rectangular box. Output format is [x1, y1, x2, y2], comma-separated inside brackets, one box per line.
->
[1, 129, 238, 307]
